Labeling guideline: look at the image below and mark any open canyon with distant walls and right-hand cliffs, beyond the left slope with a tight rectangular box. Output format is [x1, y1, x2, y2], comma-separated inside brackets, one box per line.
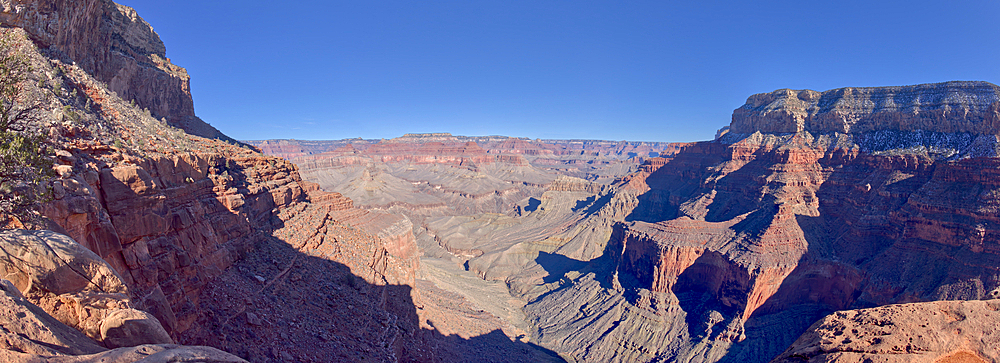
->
[244, 82, 1000, 362]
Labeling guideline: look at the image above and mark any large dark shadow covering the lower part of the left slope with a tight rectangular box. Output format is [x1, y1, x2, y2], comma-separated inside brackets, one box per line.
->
[180, 238, 563, 362]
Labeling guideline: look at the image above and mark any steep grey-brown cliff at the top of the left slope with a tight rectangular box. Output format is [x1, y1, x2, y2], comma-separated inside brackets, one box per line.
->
[0, 0, 231, 140]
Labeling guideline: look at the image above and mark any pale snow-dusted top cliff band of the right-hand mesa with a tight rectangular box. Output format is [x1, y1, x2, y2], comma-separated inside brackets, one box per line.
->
[729, 82, 1000, 134]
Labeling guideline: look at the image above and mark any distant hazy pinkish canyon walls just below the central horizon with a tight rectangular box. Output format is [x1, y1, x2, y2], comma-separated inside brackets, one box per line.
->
[254, 133, 677, 225]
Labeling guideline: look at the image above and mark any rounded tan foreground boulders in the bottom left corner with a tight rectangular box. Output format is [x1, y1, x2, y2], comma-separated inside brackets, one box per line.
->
[0, 237, 245, 363]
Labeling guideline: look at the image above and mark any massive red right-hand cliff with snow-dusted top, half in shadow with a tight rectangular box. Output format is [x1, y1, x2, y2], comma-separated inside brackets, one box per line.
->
[560, 82, 1000, 361]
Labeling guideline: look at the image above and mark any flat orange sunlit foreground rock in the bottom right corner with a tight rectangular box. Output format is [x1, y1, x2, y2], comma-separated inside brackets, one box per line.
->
[772, 300, 1000, 363]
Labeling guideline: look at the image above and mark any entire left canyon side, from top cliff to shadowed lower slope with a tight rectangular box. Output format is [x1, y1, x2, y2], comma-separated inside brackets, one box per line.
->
[0, 1, 558, 362]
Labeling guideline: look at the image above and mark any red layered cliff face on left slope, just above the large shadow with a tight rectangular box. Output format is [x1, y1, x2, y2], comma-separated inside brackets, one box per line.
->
[43, 149, 306, 334]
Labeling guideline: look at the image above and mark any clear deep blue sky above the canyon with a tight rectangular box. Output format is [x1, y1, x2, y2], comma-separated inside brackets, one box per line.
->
[119, 0, 1000, 141]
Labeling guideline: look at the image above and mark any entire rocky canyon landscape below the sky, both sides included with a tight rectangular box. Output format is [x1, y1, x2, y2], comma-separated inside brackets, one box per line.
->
[0, 0, 1000, 362]
